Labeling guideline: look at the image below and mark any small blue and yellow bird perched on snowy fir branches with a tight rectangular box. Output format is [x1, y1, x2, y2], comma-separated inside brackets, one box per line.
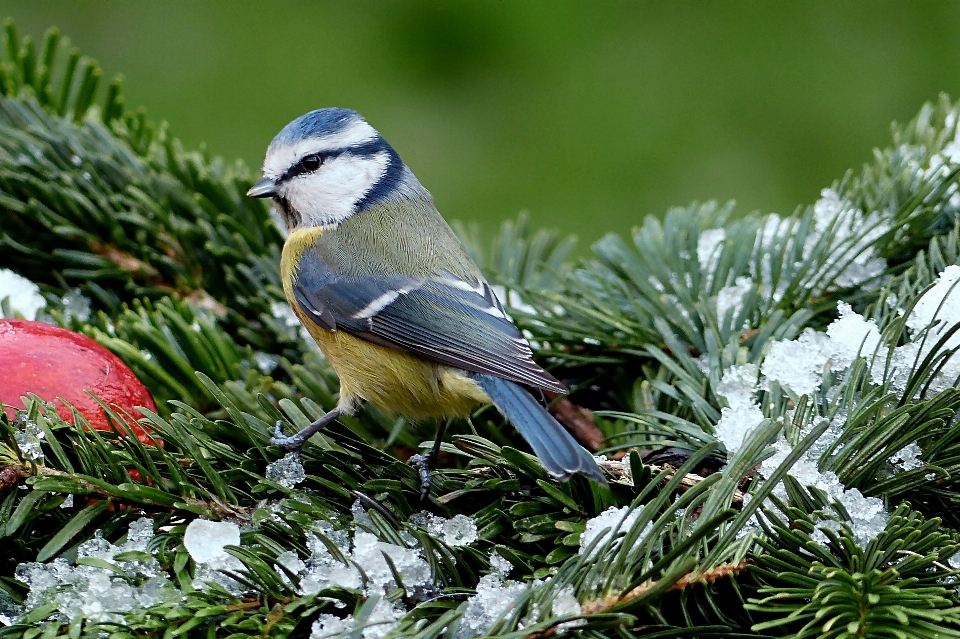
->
[247, 108, 604, 484]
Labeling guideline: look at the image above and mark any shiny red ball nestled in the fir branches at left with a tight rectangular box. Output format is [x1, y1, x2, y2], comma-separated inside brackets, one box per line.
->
[0, 318, 157, 444]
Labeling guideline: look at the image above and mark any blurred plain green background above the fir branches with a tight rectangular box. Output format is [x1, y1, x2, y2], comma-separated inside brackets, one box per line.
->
[0, 0, 960, 241]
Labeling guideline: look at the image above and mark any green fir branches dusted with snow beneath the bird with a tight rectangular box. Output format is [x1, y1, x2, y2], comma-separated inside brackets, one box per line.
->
[0, 23, 960, 639]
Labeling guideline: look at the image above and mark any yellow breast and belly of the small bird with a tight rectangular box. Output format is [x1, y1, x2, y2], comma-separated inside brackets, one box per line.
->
[280, 228, 490, 419]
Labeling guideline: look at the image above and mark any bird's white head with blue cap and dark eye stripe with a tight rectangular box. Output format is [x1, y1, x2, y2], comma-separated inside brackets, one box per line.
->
[247, 108, 408, 231]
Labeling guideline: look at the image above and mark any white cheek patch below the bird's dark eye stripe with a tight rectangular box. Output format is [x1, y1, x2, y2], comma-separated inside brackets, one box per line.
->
[280, 151, 390, 226]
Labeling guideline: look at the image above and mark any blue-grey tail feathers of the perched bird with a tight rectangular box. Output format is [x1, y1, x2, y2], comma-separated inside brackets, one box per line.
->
[470, 373, 606, 483]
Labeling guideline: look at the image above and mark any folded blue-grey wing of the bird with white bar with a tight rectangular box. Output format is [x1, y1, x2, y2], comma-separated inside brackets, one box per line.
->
[293, 246, 567, 393]
